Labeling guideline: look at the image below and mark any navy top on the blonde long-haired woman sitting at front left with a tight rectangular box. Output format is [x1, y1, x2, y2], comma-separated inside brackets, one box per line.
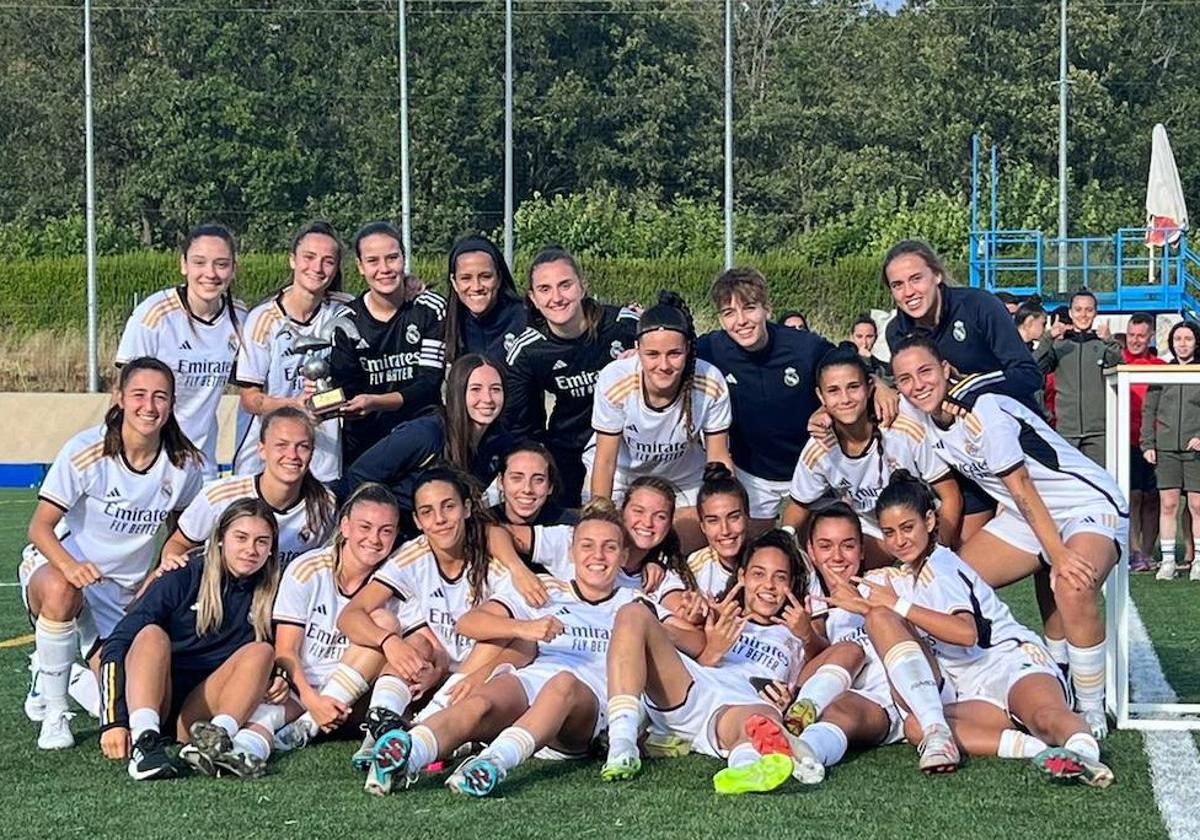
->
[100, 558, 265, 730]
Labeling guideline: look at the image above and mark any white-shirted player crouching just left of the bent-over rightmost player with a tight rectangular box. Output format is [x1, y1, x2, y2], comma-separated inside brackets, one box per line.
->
[782, 344, 962, 556]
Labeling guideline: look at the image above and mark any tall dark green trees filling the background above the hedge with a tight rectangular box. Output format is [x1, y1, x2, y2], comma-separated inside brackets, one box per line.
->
[0, 0, 1200, 262]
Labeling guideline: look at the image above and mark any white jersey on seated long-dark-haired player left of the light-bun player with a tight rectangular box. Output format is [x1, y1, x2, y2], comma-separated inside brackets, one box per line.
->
[372, 536, 509, 671]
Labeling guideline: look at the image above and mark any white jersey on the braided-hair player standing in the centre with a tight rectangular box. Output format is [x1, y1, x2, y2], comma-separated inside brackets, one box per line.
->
[583, 355, 732, 490]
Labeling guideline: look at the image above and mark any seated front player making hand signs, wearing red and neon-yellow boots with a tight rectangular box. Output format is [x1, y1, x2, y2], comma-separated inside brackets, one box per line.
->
[601, 530, 824, 793]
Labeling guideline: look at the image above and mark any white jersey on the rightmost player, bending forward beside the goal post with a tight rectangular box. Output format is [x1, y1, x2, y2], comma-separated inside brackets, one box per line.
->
[925, 394, 1129, 522]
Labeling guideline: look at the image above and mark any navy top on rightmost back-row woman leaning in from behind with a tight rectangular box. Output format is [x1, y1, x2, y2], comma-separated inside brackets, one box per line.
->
[887, 283, 1043, 414]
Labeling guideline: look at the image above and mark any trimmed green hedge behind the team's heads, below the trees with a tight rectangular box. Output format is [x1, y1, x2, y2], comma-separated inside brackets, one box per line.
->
[0, 252, 884, 335]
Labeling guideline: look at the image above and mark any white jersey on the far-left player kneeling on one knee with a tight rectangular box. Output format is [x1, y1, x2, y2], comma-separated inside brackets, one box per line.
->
[37, 426, 204, 589]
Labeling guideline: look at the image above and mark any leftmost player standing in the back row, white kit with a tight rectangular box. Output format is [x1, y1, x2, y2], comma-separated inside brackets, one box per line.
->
[116, 224, 246, 479]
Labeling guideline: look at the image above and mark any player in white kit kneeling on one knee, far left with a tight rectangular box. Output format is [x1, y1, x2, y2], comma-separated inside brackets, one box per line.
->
[18, 358, 204, 757]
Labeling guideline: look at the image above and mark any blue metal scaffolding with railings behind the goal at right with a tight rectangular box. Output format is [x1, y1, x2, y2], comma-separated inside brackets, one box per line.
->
[971, 134, 1200, 318]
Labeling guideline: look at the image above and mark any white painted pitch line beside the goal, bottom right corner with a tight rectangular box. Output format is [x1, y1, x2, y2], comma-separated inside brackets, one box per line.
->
[1129, 599, 1200, 840]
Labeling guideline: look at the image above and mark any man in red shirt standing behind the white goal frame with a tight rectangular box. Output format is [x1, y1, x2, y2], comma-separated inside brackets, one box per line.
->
[1122, 312, 1166, 571]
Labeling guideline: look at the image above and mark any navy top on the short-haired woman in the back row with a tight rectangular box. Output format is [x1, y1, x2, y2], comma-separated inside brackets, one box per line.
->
[696, 323, 834, 481]
